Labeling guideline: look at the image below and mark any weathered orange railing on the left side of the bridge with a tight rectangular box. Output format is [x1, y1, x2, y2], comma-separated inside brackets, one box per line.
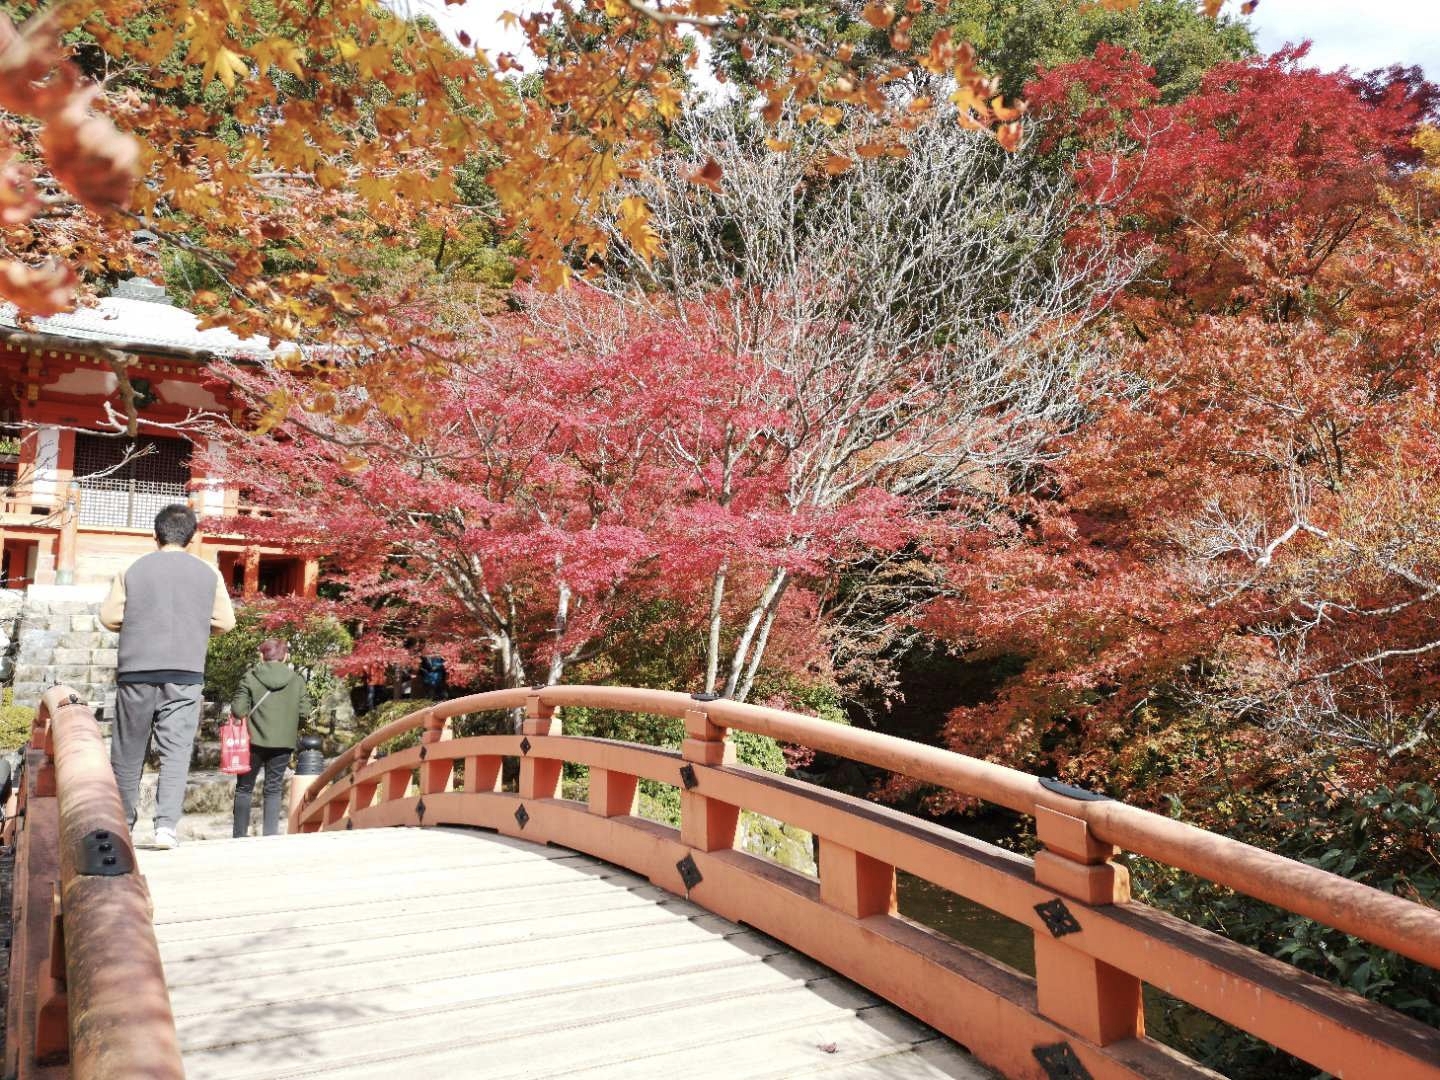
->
[4, 687, 184, 1080]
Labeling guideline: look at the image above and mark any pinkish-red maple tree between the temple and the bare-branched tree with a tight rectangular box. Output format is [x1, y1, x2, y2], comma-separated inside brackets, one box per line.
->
[208, 308, 847, 685]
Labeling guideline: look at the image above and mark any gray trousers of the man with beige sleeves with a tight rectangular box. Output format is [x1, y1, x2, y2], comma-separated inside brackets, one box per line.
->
[109, 683, 204, 829]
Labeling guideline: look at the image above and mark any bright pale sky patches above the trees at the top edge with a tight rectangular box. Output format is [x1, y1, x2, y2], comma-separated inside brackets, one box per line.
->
[393, 0, 1440, 81]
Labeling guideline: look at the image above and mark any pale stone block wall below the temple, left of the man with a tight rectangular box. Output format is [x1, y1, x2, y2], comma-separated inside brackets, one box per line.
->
[0, 585, 120, 714]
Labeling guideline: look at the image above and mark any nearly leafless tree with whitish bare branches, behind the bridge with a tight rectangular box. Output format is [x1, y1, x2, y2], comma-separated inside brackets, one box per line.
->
[540, 111, 1130, 698]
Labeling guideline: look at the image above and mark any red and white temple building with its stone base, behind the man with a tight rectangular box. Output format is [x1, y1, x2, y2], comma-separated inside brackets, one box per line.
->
[0, 278, 318, 701]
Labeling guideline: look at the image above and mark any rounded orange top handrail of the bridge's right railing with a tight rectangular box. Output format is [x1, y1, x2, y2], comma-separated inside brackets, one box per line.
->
[295, 685, 1440, 968]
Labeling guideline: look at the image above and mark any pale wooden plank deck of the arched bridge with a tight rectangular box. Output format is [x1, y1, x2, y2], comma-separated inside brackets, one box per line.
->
[140, 828, 991, 1080]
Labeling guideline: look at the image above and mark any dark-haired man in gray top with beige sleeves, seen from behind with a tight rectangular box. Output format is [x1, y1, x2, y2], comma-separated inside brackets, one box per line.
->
[99, 503, 235, 848]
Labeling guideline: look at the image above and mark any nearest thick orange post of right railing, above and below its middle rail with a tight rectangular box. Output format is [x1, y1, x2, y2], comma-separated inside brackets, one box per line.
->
[1035, 806, 1145, 1045]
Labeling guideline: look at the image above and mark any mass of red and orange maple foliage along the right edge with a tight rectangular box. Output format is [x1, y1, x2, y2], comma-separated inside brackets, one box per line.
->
[933, 49, 1440, 817]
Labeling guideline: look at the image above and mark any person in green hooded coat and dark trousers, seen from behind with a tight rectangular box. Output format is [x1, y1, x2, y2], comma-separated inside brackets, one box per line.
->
[230, 638, 310, 837]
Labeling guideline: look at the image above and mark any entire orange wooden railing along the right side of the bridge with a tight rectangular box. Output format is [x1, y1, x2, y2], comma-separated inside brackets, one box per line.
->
[291, 685, 1440, 1080]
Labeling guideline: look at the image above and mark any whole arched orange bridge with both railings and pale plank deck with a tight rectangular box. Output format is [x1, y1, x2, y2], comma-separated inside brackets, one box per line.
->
[4, 685, 1440, 1080]
